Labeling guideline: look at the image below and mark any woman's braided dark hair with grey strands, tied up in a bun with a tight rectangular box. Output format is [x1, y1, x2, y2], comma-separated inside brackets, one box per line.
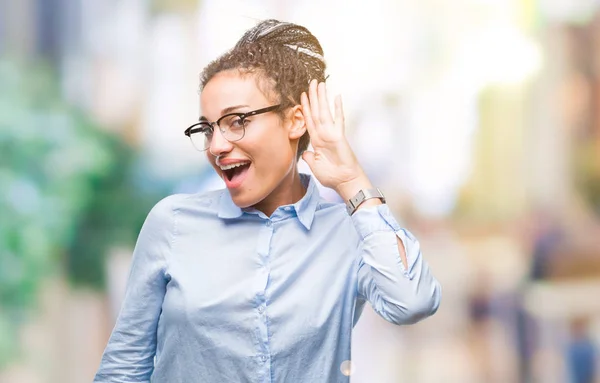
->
[200, 19, 326, 158]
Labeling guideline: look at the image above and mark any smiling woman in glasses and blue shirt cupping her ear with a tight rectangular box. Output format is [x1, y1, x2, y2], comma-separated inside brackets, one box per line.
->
[95, 20, 440, 383]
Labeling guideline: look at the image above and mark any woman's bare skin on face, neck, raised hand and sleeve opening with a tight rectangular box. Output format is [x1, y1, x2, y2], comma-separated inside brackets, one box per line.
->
[200, 70, 408, 267]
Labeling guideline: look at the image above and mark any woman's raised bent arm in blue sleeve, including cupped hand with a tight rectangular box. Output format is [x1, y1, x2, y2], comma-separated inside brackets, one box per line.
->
[301, 80, 441, 324]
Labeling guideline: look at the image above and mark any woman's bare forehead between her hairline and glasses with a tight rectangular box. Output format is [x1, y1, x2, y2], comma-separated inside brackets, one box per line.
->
[200, 70, 273, 119]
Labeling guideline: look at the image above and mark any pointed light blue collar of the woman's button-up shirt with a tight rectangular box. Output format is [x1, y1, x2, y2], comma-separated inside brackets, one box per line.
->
[218, 173, 320, 230]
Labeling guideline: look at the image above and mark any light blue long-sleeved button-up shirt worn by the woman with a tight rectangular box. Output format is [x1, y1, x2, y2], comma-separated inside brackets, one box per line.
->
[94, 175, 440, 383]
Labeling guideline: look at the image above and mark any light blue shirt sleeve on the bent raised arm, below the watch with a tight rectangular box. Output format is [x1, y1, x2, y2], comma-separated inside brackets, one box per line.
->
[352, 204, 441, 324]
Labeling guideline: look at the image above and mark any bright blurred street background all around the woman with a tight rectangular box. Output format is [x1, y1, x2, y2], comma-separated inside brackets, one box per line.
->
[0, 0, 600, 383]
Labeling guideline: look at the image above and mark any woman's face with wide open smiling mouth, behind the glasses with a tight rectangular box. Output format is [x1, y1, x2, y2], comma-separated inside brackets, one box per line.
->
[200, 70, 305, 214]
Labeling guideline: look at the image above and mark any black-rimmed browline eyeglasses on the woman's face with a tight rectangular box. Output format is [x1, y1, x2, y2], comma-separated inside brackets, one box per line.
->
[184, 104, 281, 152]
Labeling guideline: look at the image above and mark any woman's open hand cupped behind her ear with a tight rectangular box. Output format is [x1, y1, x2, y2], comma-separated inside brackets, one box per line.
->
[301, 80, 372, 199]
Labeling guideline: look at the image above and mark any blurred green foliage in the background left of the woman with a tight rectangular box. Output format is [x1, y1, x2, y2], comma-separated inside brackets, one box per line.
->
[0, 60, 162, 369]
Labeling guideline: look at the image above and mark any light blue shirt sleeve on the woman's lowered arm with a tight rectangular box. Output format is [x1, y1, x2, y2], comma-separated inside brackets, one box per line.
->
[94, 197, 173, 383]
